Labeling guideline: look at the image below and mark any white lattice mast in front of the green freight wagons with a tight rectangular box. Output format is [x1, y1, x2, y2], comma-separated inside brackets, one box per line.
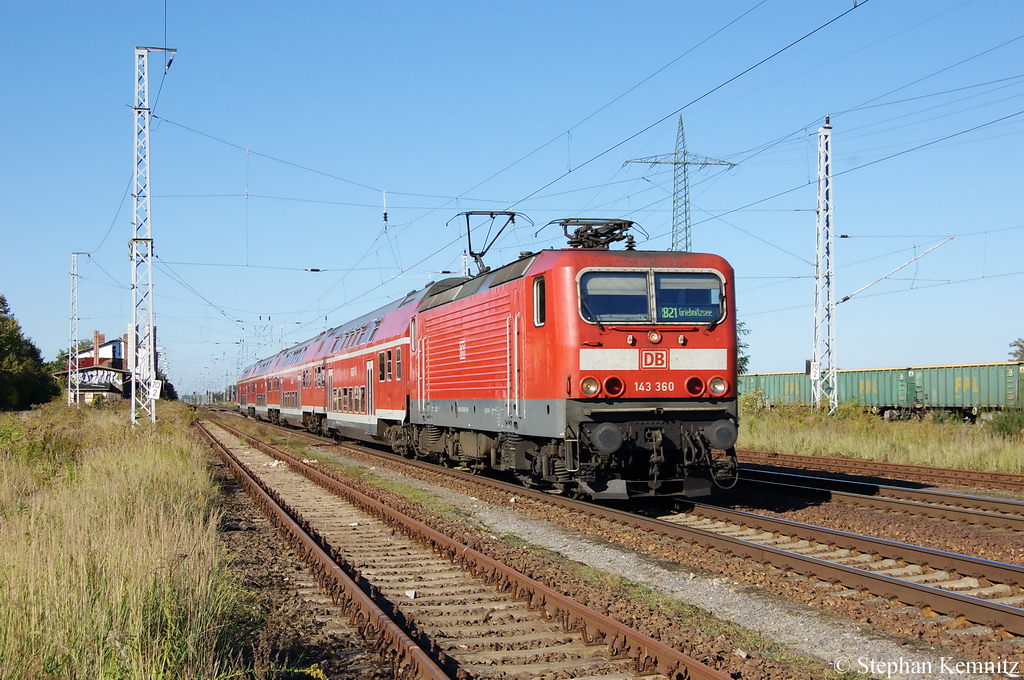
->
[811, 116, 839, 416]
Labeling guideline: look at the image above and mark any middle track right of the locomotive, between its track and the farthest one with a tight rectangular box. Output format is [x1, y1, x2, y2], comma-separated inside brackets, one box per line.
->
[742, 470, 1024, 532]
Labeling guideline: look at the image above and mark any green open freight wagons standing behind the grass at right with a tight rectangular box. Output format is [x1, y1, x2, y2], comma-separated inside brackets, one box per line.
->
[738, 362, 1024, 421]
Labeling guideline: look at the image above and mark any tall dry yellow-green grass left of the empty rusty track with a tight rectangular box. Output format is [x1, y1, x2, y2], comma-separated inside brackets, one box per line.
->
[0, 402, 261, 679]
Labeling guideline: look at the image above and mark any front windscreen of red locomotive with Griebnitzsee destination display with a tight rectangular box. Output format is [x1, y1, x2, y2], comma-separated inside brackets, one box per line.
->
[580, 270, 725, 324]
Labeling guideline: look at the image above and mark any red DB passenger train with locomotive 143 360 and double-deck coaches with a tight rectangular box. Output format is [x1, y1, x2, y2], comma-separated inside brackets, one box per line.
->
[238, 212, 738, 500]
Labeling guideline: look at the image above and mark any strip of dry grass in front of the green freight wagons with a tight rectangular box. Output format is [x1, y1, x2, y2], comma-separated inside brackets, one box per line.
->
[736, 387, 1024, 473]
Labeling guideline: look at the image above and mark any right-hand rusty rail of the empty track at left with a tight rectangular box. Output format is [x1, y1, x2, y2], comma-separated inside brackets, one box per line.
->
[211, 423, 728, 680]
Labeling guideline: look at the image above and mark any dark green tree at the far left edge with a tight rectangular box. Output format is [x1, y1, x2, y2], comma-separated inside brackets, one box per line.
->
[0, 295, 60, 411]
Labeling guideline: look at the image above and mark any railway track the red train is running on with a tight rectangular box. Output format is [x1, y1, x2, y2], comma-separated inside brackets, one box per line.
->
[205, 411, 1024, 655]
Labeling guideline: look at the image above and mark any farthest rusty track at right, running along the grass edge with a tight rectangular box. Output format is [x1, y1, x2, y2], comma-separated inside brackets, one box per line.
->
[736, 449, 1024, 494]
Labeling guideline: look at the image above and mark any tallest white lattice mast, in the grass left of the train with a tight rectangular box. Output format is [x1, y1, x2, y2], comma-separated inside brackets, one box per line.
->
[129, 47, 176, 425]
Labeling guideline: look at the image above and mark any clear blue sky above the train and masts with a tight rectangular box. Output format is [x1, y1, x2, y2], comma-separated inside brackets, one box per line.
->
[0, 0, 1024, 393]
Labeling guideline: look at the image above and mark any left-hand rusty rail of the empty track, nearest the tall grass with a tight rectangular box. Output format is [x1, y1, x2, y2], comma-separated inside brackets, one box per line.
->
[196, 421, 450, 680]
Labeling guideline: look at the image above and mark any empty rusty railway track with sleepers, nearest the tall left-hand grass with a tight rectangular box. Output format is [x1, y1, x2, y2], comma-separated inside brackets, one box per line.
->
[201, 423, 727, 680]
